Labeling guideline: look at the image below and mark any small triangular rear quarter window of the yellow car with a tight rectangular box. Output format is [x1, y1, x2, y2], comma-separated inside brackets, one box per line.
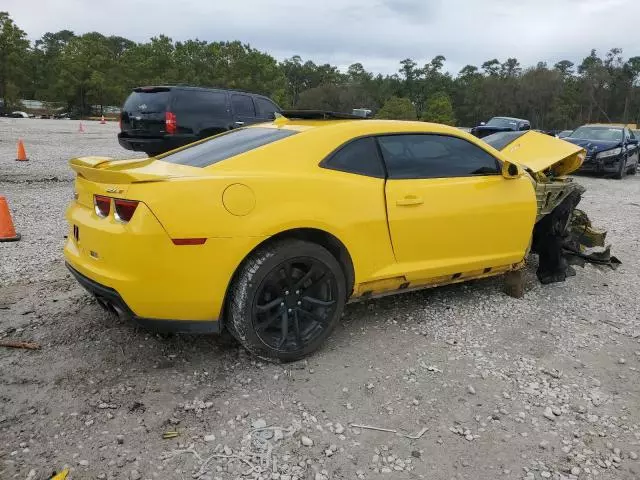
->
[321, 137, 385, 178]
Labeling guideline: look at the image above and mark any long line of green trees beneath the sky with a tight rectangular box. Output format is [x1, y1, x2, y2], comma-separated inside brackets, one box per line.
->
[0, 12, 640, 129]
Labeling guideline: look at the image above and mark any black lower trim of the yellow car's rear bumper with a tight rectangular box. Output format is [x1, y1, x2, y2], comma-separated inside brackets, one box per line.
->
[65, 263, 221, 333]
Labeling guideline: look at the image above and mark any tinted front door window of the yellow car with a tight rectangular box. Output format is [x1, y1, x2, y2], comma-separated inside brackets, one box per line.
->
[378, 134, 500, 179]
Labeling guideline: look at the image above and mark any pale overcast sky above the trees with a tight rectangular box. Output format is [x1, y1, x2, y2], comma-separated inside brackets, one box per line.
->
[5, 0, 640, 73]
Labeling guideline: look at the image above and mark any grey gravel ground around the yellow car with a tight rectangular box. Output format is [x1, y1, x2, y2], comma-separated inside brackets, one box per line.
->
[0, 119, 640, 480]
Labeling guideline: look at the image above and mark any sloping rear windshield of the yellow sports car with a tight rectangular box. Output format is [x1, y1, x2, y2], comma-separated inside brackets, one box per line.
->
[159, 127, 298, 167]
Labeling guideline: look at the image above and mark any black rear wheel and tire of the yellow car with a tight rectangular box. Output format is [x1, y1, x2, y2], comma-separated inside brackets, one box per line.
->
[226, 239, 346, 362]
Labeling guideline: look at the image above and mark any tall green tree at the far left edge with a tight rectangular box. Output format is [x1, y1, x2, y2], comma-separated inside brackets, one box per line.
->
[0, 12, 29, 109]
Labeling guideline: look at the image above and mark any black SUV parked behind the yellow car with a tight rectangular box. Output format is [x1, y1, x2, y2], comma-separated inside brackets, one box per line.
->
[118, 86, 281, 156]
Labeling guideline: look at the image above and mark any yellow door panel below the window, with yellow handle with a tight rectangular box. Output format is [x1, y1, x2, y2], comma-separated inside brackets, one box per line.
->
[386, 175, 536, 282]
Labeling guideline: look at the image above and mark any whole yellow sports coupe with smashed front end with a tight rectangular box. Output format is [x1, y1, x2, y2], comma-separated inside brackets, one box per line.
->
[64, 112, 584, 361]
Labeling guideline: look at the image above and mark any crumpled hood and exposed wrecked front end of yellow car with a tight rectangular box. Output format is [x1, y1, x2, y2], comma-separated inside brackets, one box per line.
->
[483, 131, 621, 284]
